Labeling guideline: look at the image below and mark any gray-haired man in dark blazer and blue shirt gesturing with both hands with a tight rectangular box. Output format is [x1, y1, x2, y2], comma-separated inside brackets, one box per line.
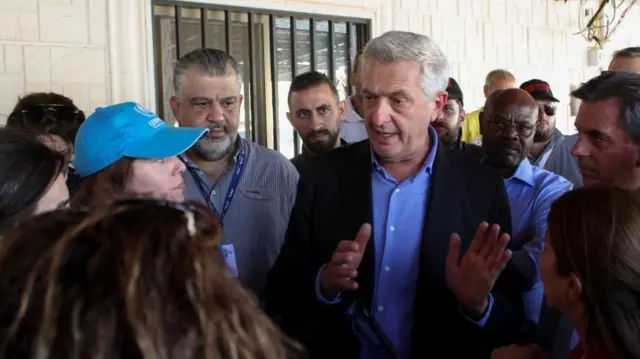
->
[266, 31, 523, 359]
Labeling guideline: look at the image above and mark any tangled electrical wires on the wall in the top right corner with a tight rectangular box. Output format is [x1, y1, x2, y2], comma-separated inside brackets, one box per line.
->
[576, 0, 637, 48]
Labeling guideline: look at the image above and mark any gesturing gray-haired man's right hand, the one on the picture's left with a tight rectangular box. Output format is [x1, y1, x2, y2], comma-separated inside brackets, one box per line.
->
[320, 223, 371, 298]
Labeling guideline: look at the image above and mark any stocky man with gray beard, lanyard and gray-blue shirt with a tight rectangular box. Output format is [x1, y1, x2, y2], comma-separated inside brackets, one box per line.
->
[171, 48, 299, 297]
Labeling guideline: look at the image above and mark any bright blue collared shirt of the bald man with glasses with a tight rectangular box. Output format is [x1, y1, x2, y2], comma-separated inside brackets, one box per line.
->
[505, 160, 573, 323]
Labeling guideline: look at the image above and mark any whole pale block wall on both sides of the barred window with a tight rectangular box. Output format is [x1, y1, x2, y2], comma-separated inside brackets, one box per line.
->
[0, 0, 640, 132]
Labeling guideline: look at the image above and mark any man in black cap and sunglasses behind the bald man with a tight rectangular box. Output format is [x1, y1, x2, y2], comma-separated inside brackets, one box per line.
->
[520, 79, 564, 168]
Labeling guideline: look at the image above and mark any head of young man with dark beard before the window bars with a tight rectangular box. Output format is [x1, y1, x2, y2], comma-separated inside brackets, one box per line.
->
[287, 71, 346, 173]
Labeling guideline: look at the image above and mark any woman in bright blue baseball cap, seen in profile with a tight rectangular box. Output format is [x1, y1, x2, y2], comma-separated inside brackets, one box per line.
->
[72, 102, 209, 207]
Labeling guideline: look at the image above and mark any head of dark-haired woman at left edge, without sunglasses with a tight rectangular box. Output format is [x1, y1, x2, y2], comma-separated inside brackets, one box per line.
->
[0, 128, 69, 236]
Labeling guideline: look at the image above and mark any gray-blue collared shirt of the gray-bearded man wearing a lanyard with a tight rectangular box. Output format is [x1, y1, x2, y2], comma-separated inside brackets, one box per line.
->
[180, 139, 299, 297]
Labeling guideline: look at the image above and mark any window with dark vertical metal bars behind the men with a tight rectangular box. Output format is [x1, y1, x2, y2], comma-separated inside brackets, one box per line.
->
[153, 0, 370, 158]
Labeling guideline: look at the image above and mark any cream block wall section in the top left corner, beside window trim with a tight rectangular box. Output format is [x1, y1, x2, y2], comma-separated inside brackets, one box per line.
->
[0, 0, 109, 122]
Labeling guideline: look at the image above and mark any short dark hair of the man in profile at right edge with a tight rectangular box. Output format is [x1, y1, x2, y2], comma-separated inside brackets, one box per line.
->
[571, 71, 640, 143]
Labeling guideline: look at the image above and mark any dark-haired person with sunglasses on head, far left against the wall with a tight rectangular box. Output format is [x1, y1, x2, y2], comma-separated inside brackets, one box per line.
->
[7, 92, 85, 192]
